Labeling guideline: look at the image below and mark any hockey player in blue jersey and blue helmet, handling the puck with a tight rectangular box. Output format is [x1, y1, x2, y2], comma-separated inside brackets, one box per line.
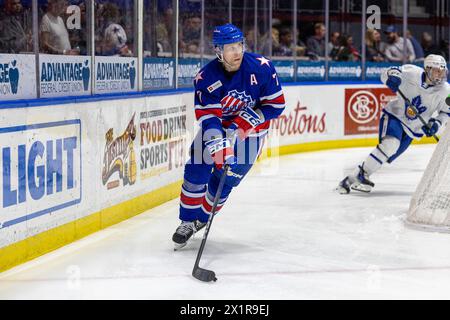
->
[172, 24, 285, 249]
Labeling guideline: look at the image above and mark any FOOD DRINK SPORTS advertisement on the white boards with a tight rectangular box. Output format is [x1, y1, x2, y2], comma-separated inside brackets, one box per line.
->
[139, 105, 186, 180]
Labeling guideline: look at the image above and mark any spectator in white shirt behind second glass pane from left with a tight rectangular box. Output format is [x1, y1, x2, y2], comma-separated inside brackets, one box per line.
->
[40, 0, 80, 55]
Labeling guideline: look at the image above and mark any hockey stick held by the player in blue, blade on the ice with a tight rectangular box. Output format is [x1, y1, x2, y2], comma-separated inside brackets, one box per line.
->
[192, 164, 229, 282]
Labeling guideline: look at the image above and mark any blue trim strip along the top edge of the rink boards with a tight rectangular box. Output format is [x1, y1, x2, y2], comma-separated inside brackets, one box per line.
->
[0, 81, 382, 109]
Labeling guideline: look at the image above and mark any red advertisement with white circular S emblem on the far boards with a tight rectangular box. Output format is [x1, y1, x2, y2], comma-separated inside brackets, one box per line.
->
[344, 88, 396, 135]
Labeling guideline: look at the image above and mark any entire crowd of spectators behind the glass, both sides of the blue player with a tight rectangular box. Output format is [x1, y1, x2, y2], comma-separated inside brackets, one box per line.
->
[0, 0, 449, 62]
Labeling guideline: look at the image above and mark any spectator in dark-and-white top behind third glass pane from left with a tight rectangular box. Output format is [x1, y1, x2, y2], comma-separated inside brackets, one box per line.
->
[101, 3, 133, 57]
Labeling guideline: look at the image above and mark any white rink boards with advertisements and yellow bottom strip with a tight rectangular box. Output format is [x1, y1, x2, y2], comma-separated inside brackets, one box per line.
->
[0, 84, 438, 271]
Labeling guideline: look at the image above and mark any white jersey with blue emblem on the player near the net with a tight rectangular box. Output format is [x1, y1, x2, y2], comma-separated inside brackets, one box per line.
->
[381, 64, 450, 139]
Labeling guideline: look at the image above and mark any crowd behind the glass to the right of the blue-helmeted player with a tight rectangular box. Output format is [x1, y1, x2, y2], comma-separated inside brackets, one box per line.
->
[264, 23, 449, 63]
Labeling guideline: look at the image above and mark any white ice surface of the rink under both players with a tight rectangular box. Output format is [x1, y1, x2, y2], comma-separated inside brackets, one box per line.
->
[0, 145, 450, 299]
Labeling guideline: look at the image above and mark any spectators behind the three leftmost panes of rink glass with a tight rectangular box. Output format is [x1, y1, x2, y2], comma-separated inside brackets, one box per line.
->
[0, 0, 134, 56]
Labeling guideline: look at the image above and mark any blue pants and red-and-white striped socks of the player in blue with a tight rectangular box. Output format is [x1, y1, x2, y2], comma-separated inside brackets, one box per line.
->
[180, 131, 267, 222]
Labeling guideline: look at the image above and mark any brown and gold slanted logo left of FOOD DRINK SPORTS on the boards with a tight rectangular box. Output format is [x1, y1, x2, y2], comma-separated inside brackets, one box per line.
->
[102, 114, 137, 189]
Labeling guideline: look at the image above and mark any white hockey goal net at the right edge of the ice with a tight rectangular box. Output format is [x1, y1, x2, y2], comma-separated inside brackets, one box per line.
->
[406, 125, 450, 232]
